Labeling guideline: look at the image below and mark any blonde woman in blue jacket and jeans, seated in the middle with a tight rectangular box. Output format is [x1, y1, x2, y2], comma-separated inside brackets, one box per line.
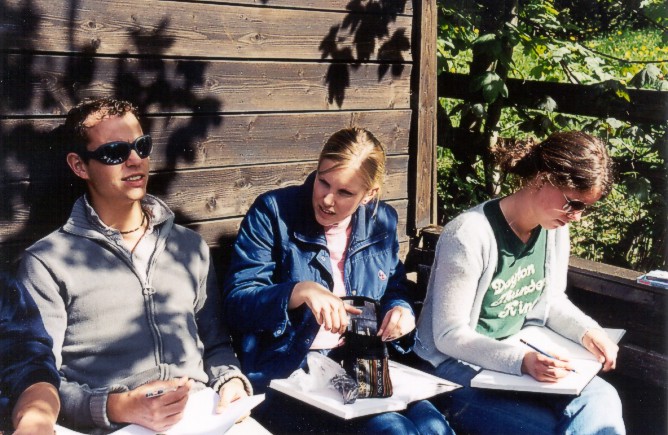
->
[225, 128, 450, 434]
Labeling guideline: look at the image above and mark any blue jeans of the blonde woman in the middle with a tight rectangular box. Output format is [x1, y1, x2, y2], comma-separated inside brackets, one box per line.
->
[252, 389, 454, 435]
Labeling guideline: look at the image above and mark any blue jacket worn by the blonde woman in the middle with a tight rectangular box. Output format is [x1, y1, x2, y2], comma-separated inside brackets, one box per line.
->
[224, 173, 412, 392]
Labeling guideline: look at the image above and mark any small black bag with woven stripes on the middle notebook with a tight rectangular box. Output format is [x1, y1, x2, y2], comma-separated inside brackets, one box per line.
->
[341, 296, 392, 398]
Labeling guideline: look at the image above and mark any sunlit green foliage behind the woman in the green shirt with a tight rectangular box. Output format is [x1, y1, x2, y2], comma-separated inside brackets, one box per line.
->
[438, 0, 668, 270]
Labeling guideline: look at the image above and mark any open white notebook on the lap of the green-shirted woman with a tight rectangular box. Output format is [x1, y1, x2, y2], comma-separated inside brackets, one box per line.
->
[471, 326, 626, 395]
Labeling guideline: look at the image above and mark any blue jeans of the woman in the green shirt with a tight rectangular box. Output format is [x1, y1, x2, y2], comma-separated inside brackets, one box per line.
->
[421, 360, 626, 435]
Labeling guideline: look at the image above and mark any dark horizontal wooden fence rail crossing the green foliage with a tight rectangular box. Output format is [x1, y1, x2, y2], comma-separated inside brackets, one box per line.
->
[438, 73, 668, 123]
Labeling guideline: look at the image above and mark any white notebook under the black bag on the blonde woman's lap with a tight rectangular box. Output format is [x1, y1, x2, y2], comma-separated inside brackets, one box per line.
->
[269, 361, 461, 420]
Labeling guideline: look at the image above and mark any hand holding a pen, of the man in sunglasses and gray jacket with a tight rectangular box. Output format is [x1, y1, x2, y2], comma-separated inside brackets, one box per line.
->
[107, 377, 193, 432]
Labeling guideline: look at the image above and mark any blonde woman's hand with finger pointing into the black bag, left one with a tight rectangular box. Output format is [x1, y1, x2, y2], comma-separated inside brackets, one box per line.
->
[288, 281, 362, 334]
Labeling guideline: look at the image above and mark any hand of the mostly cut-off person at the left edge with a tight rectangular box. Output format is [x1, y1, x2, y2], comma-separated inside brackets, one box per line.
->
[12, 382, 60, 435]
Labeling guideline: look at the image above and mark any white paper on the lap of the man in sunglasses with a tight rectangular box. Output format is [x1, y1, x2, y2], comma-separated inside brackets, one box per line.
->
[112, 388, 264, 435]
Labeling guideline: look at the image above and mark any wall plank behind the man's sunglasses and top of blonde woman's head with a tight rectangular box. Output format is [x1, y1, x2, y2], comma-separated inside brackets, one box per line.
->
[0, 110, 411, 182]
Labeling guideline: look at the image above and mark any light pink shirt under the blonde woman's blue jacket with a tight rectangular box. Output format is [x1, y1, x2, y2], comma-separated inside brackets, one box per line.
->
[311, 216, 352, 349]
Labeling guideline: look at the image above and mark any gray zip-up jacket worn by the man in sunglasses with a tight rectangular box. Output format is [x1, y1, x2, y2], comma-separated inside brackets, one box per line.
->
[19, 195, 251, 429]
